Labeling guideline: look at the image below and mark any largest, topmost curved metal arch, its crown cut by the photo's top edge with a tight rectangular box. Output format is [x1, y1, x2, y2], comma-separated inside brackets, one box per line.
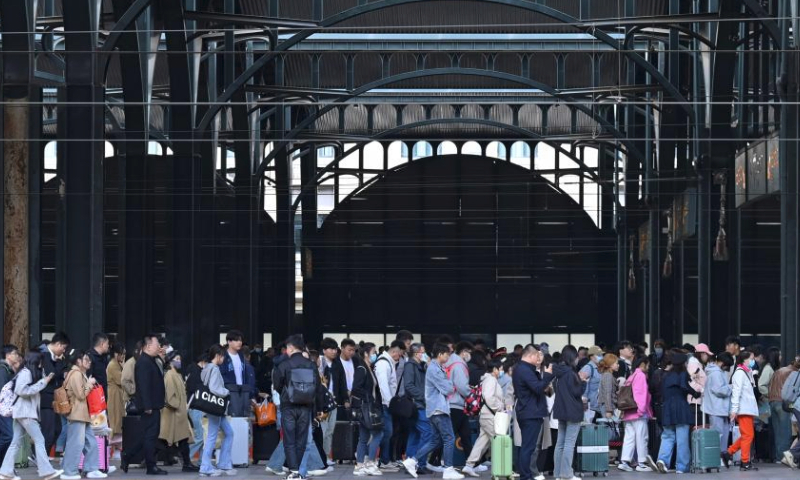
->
[198, 0, 695, 131]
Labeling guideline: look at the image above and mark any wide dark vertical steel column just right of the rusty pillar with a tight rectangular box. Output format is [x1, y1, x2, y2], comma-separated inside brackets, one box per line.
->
[56, 0, 105, 346]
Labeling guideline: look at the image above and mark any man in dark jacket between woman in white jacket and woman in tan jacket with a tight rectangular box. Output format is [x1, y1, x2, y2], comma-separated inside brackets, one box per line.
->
[39, 332, 69, 452]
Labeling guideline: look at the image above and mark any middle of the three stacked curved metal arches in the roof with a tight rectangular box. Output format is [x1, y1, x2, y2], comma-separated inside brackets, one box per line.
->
[256, 67, 644, 175]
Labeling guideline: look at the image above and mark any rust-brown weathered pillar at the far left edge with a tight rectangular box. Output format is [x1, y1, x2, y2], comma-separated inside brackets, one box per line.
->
[3, 97, 31, 348]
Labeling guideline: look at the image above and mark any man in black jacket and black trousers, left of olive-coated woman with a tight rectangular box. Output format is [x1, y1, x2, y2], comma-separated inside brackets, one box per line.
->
[121, 334, 167, 475]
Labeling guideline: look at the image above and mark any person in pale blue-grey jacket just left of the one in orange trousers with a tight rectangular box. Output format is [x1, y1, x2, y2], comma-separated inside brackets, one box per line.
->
[702, 352, 734, 458]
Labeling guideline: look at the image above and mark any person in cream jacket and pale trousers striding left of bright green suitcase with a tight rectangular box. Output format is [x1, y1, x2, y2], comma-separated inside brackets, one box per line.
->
[461, 359, 506, 477]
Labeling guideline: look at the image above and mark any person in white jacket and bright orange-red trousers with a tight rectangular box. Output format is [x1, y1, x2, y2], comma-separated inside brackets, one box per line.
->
[722, 350, 758, 471]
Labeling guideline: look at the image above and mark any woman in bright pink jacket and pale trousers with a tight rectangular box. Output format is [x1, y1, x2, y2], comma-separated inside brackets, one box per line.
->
[617, 356, 653, 472]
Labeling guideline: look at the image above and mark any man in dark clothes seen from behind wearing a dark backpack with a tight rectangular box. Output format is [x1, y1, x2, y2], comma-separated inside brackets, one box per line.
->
[272, 335, 320, 480]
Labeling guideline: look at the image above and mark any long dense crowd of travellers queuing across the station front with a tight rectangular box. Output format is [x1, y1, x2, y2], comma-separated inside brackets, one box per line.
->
[0, 330, 800, 480]
